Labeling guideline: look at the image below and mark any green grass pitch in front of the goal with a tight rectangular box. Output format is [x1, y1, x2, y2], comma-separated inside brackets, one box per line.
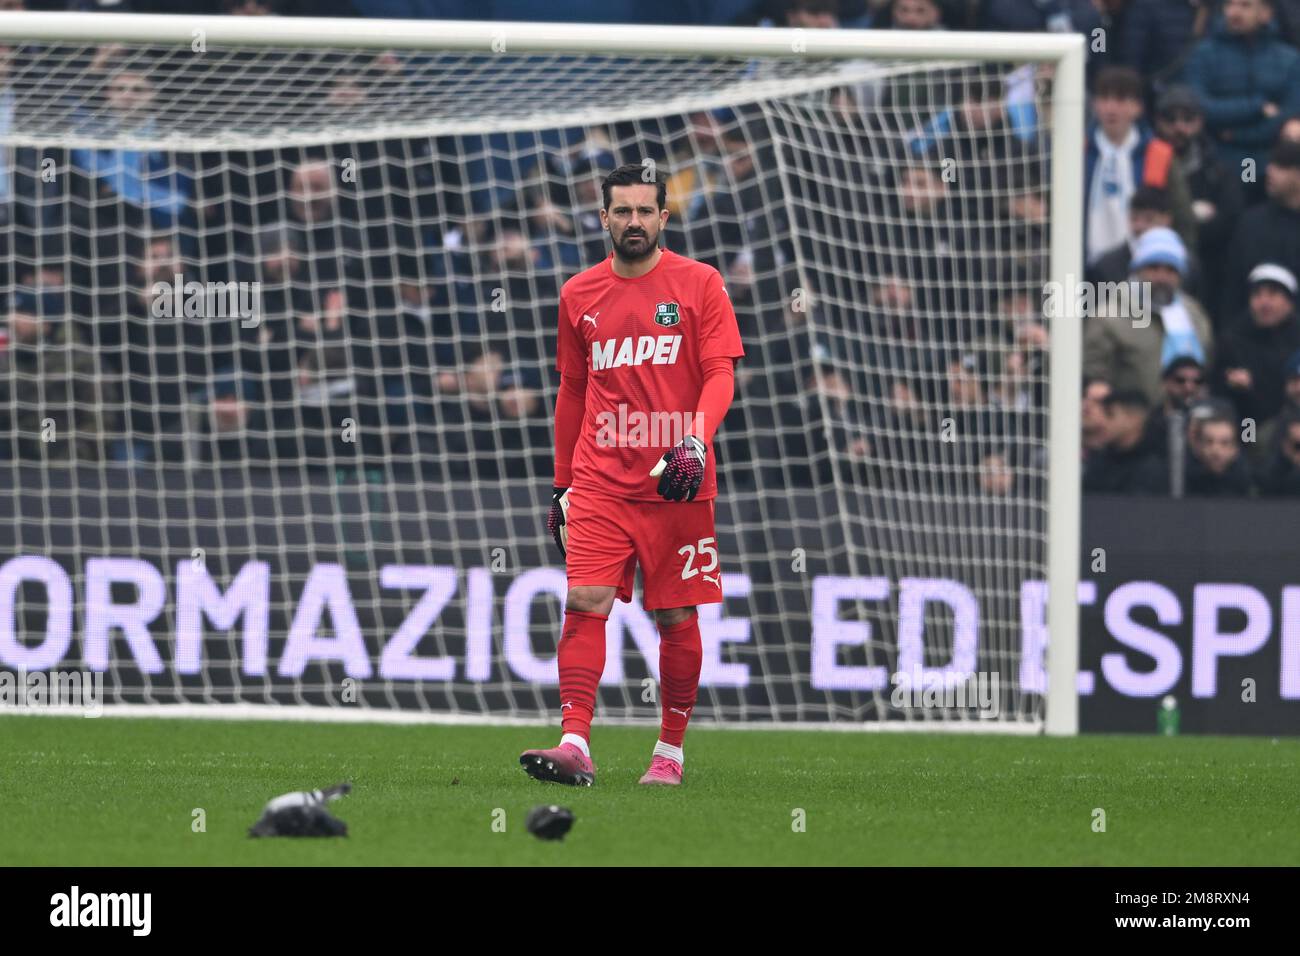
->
[0, 715, 1300, 866]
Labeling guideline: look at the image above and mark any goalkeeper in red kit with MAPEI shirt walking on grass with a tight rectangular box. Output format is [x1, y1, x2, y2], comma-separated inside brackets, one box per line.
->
[519, 164, 745, 786]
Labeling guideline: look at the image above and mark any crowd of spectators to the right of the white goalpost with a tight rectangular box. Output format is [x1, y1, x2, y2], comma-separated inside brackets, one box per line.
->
[1083, 0, 1300, 496]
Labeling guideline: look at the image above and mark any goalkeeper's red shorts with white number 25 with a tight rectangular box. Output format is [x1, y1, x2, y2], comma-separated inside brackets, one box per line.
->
[566, 489, 723, 611]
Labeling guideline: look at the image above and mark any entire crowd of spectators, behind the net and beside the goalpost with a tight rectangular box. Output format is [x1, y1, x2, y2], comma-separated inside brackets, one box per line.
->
[0, 0, 1300, 497]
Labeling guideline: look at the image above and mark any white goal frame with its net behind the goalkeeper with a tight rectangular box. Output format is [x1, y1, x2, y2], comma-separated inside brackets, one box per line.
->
[0, 14, 1082, 731]
